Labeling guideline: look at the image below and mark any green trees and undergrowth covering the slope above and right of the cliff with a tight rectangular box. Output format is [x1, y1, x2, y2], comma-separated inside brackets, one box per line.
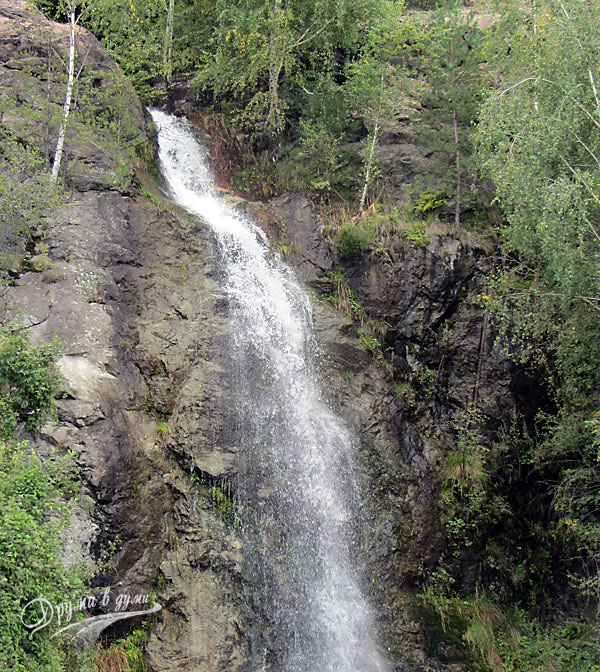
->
[0, 0, 600, 671]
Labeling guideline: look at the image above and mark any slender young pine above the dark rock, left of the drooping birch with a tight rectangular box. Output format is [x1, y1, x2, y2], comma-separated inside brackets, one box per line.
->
[403, 1, 486, 224]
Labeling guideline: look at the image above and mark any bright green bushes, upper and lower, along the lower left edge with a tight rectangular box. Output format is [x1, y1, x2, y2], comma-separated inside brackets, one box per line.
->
[0, 325, 83, 672]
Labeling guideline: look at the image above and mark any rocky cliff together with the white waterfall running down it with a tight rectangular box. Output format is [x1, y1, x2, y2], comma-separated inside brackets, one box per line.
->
[0, 0, 531, 672]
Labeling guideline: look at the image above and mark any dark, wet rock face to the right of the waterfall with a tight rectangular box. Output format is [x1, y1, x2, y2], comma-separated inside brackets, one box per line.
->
[268, 197, 533, 670]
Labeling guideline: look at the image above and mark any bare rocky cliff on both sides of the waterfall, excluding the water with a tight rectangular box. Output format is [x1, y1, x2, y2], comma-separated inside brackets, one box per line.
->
[0, 0, 528, 672]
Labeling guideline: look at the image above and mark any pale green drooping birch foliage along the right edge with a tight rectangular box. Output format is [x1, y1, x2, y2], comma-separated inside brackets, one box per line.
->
[477, 0, 600, 595]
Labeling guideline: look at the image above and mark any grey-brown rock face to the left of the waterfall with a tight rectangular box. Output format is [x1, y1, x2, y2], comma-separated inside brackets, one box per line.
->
[0, 0, 245, 672]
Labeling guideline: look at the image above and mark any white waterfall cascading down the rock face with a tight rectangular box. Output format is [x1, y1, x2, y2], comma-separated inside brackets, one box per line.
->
[152, 110, 387, 672]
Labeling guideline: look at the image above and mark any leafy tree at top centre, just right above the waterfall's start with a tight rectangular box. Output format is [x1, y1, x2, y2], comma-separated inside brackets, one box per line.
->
[195, 0, 378, 138]
